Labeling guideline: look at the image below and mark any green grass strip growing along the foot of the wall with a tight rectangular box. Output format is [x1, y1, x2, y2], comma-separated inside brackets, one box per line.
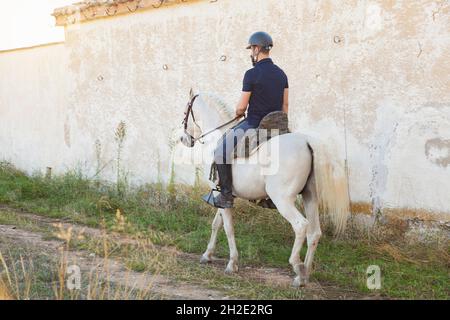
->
[0, 163, 450, 299]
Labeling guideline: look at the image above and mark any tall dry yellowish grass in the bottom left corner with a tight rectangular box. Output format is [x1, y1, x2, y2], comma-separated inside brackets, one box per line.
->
[0, 219, 160, 300]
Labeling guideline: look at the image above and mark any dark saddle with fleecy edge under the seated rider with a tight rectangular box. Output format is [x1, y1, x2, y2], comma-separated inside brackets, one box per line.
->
[209, 111, 290, 209]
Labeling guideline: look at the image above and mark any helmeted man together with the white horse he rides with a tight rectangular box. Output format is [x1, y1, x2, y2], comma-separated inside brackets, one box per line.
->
[180, 32, 350, 287]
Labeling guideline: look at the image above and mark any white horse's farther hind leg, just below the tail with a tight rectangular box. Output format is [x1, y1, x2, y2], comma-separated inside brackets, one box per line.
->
[302, 175, 322, 281]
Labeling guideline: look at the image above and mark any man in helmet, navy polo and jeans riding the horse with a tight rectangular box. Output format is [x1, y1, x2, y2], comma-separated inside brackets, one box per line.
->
[203, 32, 289, 208]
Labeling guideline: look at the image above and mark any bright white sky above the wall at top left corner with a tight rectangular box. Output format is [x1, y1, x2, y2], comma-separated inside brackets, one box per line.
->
[0, 0, 74, 50]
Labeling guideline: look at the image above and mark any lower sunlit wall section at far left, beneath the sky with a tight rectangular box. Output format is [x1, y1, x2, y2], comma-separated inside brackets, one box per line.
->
[0, 44, 71, 171]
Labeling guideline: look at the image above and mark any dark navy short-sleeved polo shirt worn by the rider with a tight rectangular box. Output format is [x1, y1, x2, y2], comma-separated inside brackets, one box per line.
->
[242, 58, 289, 127]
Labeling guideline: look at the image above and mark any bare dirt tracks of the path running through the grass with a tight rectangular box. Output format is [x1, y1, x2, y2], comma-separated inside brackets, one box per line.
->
[0, 205, 376, 300]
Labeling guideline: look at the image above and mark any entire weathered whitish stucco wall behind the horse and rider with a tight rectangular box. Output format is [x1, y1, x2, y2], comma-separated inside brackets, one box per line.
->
[0, 0, 450, 220]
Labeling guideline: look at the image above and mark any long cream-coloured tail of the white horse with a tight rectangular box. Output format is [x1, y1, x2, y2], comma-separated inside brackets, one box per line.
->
[307, 138, 350, 235]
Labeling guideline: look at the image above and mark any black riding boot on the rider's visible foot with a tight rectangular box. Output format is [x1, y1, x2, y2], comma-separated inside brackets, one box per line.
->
[202, 164, 234, 209]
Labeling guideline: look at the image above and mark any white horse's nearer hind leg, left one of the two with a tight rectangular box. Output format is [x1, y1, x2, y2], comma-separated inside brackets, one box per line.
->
[268, 190, 309, 287]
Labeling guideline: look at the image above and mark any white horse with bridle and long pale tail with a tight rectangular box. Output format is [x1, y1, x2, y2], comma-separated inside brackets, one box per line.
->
[181, 89, 349, 287]
